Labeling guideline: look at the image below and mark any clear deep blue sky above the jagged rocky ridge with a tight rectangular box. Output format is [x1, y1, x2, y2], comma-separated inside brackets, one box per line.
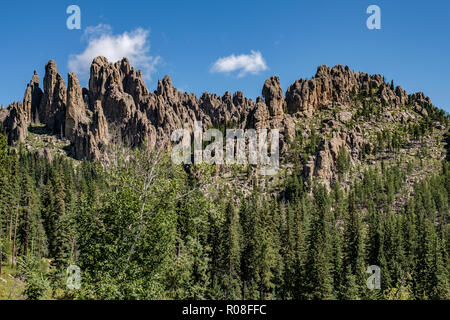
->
[0, 0, 450, 112]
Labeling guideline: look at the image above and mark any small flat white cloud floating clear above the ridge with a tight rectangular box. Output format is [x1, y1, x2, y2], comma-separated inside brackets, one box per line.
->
[211, 50, 268, 77]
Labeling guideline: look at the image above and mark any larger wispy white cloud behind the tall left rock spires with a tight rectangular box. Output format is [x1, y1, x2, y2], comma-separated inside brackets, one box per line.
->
[68, 24, 160, 79]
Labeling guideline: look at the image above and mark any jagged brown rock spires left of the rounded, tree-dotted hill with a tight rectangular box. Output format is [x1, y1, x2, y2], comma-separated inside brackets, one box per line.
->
[4, 57, 296, 159]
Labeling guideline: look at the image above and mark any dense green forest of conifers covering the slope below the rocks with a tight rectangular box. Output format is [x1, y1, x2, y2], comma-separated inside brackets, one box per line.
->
[0, 130, 450, 300]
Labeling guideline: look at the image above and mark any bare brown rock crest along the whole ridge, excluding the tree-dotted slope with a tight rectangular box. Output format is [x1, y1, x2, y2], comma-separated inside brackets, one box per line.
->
[0, 57, 442, 185]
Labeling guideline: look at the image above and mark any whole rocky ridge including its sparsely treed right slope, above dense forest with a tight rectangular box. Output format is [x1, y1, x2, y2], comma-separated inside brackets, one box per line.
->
[0, 57, 448, 186]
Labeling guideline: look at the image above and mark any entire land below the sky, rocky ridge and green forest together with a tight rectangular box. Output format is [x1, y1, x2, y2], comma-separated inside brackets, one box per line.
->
[0, 58, 450, 300]
